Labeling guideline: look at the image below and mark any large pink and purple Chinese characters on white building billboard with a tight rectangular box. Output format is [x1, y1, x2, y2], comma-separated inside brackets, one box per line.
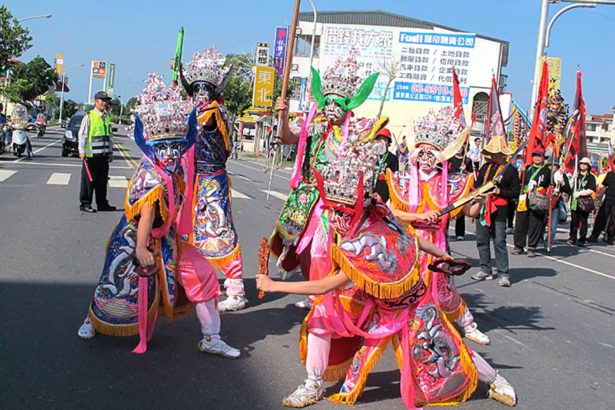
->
[320, 25, 395, 100]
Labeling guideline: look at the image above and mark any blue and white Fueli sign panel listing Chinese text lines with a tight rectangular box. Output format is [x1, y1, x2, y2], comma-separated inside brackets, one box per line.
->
[393, 31, 476, 104]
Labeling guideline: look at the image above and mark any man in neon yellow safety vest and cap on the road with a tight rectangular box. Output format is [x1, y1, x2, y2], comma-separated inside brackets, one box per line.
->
[79, 91, 116, 213]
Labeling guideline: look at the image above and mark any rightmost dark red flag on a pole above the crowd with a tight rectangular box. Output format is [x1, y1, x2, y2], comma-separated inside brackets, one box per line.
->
[564, 71, 588, 173]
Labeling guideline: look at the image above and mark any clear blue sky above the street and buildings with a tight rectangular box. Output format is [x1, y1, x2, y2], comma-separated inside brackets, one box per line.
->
[3, 0, 615, 114]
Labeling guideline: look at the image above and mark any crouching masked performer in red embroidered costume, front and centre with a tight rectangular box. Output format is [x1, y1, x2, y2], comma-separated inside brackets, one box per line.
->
[256, 117, 516, 409]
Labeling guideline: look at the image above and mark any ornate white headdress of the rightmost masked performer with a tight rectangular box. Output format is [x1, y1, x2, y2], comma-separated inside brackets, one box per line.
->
[414, 106, 469, 161]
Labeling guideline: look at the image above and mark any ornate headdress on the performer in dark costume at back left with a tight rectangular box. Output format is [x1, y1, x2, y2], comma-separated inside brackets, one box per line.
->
[179, 47, 231, 96]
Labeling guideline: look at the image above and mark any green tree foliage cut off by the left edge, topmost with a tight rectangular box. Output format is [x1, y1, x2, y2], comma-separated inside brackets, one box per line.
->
[0, 5, 32, 71]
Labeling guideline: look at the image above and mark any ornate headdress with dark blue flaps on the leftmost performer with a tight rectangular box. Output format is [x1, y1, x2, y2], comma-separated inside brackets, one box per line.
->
[134, 73, 196, 156]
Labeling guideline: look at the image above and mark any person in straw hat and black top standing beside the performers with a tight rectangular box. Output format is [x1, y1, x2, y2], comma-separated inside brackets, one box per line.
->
[470, 134, 520, 287]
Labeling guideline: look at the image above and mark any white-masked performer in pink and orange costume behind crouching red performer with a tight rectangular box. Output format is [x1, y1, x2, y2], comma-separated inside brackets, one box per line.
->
[388, 107, 490, 345]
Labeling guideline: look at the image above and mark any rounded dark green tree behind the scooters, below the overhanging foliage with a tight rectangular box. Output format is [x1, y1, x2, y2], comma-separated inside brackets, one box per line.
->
[6, 56, 58, 106]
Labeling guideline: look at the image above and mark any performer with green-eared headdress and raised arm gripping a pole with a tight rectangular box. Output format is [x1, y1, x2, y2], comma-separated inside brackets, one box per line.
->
[271, 51, 378, 308]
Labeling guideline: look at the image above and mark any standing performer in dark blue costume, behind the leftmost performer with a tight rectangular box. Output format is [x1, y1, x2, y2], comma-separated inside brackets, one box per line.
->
[180, 47, 248, 312]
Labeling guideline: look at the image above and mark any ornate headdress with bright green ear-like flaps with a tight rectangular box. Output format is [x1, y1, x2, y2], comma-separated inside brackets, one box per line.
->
[311, 50, 379, 111]
